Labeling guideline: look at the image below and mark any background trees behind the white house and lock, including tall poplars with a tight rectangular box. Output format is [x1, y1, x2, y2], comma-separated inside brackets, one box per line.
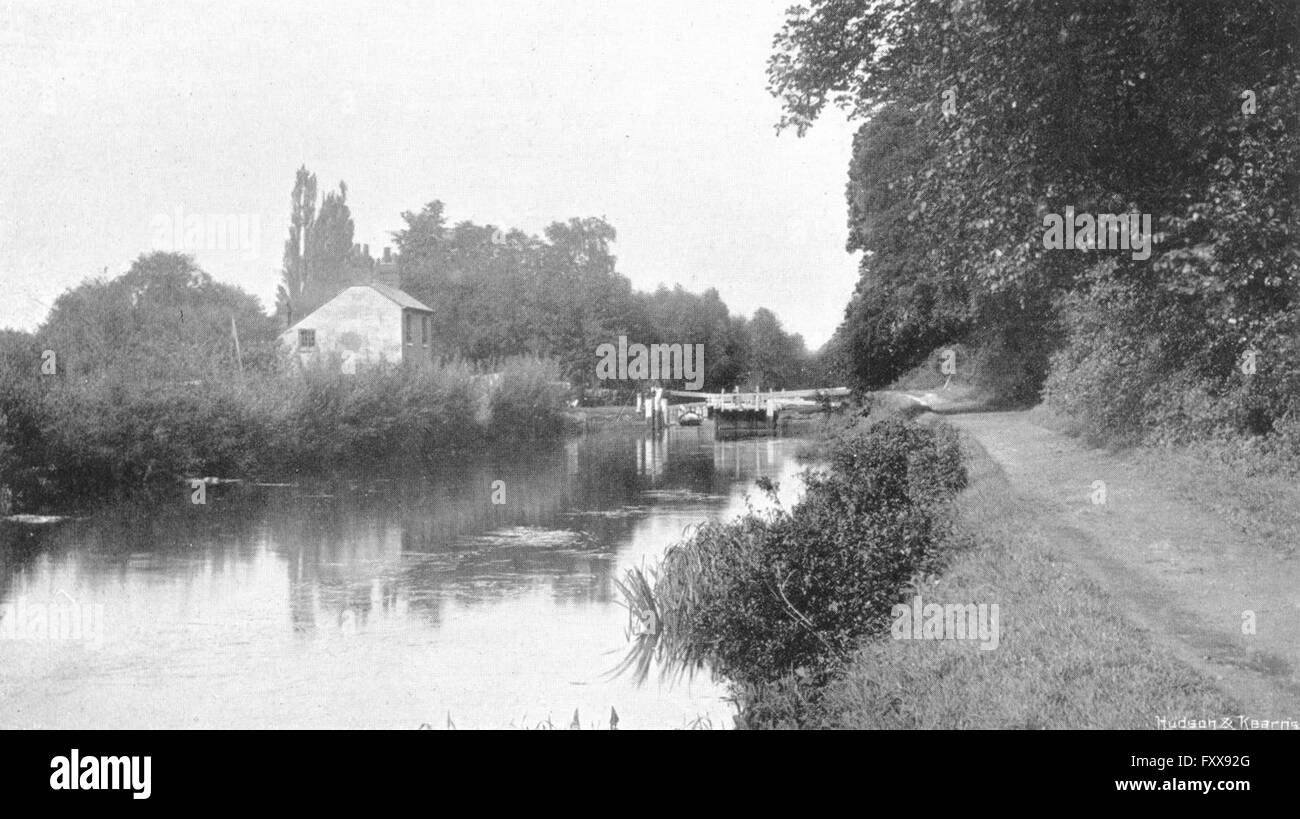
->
[277, 168, 818, 390]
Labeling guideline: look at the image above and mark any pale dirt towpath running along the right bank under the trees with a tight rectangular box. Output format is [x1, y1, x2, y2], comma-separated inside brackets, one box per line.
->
[920, 408, 1300, 728]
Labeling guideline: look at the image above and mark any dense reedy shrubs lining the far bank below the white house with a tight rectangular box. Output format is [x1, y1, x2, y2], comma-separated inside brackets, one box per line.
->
[0, 359, 563, 511]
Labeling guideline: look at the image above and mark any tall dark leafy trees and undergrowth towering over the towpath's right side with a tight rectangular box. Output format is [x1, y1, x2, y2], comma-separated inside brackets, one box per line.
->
[770, 0, 1300, 452]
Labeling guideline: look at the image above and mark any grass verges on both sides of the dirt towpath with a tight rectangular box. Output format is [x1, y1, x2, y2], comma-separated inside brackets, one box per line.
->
[780, 406, 1300, 729]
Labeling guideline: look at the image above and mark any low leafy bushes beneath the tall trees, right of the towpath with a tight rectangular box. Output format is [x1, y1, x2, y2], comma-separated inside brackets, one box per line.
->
[1044, 269, 1300, 468]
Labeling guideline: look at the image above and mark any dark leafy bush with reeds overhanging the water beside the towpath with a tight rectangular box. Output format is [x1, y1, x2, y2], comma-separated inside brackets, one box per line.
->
[620, 419, 966, 706]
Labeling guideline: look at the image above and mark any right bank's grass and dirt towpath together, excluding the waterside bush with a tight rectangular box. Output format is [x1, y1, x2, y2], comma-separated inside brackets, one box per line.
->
[748, 400, 1300, 729]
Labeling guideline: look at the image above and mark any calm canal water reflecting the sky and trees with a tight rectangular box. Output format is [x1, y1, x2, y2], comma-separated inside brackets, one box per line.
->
[0, 429, 800, 728]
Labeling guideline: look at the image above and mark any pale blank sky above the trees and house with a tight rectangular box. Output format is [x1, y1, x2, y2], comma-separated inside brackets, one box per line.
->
[0, 0, 857, 347]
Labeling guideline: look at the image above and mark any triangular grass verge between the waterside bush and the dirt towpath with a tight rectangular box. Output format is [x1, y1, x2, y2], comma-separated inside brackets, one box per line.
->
[750, 428, 1236, 729]
